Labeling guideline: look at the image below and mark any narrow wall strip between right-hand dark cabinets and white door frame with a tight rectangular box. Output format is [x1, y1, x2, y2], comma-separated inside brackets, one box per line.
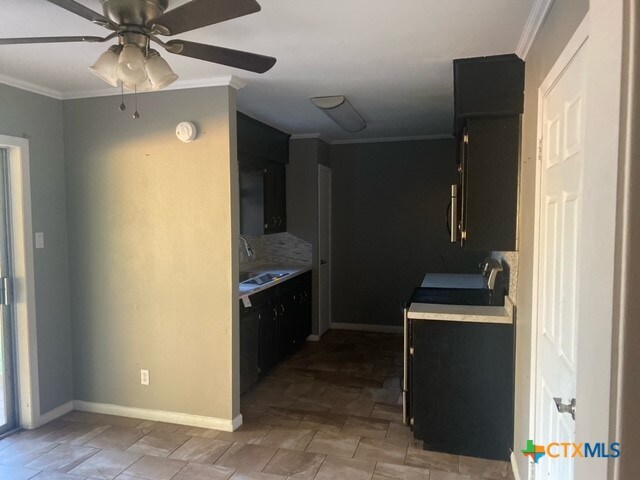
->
[514, 0, 589, 478]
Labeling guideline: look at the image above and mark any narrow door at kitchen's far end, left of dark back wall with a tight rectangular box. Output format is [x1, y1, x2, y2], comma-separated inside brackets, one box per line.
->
[318, 165, 331, 336]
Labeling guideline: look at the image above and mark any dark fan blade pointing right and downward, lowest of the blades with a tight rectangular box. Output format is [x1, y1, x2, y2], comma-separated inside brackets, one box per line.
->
[166, 40, 276, 73]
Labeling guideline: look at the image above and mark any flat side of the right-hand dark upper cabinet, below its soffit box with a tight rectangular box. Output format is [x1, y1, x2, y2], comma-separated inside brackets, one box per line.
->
[462, 115, 520, 251]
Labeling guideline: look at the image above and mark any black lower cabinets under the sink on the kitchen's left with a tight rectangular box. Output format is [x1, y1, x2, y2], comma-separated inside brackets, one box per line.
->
[240, 272, 311, 393]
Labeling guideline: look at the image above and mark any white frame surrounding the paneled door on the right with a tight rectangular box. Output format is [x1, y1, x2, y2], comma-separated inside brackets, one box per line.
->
[528, 0, 624, 480]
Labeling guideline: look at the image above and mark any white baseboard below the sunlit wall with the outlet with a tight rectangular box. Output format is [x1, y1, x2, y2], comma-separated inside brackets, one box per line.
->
[73, 400, 242, 432]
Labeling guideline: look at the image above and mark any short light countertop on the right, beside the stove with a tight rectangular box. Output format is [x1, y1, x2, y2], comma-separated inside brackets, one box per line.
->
[407, 296, 514, 324]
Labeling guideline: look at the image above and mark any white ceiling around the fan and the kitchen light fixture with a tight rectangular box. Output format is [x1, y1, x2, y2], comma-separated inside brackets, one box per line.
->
[0, 0, 535, 141]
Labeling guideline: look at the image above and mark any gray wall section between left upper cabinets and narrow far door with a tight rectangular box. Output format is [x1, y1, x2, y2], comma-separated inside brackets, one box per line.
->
[287, 138, 330, 334]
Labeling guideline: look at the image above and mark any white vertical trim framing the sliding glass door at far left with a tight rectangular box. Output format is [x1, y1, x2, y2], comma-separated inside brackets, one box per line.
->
[0, 135, 40, 428]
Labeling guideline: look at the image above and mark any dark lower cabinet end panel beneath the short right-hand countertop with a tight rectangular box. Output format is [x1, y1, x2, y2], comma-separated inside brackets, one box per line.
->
[410, 320, 514, 461]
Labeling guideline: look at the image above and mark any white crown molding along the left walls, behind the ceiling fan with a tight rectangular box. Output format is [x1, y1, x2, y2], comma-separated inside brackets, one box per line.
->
[0, 74, 247, 100]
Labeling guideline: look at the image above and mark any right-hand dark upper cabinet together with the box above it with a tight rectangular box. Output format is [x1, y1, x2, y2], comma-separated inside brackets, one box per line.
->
[450, 55, 524, 251]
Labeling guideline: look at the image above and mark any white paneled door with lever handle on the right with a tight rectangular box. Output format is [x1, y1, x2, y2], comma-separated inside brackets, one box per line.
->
[534, 39, 586, 480]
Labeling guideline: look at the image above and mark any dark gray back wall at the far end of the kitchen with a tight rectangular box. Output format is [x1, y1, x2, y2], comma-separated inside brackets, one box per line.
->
[331, 139, 485, 325]
